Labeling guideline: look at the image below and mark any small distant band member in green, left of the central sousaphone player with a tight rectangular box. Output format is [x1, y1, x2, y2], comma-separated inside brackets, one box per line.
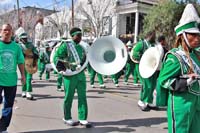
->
[38, 43, 51, 81]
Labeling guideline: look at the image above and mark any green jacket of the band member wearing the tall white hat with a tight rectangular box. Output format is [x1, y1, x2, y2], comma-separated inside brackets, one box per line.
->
[157, 47, 200, 105]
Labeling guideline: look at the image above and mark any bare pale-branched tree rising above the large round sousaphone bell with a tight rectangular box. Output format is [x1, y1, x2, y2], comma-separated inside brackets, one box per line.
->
[75, 0, 115, 37]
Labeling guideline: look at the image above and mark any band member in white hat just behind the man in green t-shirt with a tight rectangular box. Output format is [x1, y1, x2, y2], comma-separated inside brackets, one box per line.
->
[17, 33, 38, 100]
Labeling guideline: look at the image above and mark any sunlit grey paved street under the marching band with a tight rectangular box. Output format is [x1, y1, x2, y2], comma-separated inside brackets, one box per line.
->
[8, 71, 167, 133]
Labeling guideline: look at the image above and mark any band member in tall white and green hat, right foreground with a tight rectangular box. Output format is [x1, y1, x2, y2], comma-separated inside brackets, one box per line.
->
[158, 4, 200, 133]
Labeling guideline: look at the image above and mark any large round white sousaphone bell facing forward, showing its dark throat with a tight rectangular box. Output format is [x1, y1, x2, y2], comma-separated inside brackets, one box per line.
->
[88, 36, 128, 75]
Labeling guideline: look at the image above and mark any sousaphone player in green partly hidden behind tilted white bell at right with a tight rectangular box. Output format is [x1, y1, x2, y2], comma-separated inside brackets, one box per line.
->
[132, 31, 158, 111]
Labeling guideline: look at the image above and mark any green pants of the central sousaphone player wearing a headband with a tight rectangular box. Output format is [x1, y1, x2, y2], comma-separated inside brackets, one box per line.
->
[63, 76, 88, 120]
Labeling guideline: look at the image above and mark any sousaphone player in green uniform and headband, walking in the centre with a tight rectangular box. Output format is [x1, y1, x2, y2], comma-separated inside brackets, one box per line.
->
[54, 27, 92, 128]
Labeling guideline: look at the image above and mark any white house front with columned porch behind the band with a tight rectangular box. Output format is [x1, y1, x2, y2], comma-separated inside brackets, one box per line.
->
[112, 0, 158, 42]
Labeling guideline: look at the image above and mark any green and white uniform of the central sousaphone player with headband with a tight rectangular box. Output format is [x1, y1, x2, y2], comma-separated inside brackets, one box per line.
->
[54, 41, 88, 120]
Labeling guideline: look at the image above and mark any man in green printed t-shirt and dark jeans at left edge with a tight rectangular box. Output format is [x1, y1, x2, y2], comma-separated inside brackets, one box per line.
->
[0, 24, 26, 132]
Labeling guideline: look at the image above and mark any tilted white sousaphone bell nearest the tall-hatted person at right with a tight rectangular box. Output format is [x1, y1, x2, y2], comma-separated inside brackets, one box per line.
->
[139, 44, 164, 78]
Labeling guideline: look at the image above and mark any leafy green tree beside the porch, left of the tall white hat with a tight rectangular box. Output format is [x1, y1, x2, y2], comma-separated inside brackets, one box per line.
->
[142, 0, 184, 47]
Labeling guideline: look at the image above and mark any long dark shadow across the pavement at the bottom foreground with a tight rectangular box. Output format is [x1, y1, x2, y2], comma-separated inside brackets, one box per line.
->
[21, 117, 167, 133]
